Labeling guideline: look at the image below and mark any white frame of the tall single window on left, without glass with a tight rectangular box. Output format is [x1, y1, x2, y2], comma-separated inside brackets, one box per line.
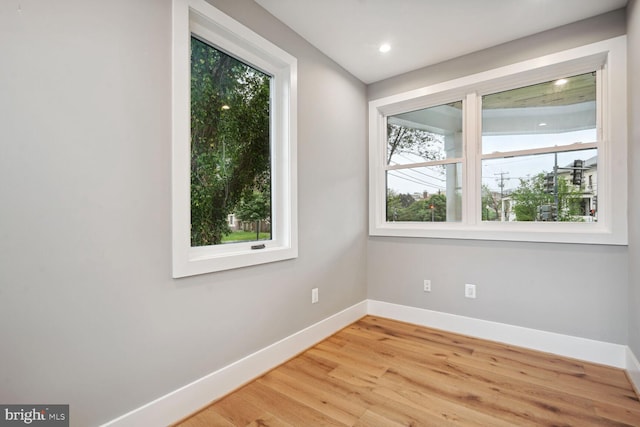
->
[172, 0, 298, 278]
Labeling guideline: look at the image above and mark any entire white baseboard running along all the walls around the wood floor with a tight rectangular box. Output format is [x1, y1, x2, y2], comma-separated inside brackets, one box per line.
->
[102, 300, 640, 427]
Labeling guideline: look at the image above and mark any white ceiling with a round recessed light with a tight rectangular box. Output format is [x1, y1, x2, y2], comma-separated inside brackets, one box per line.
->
[255, 0, 627, 83]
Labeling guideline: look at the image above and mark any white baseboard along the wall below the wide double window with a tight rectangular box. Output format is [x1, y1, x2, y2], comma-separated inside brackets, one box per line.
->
[367, 300, 627, 369]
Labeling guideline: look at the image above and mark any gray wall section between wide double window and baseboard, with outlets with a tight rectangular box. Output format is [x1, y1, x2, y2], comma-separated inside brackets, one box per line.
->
[368, 238, 627, 344]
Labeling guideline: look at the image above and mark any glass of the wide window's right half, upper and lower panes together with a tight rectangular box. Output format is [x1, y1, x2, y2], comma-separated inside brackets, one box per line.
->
[481, 70, 598, 222]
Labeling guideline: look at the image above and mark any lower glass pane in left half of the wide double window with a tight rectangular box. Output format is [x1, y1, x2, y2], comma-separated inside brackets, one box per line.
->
[387, 163, 462, 222]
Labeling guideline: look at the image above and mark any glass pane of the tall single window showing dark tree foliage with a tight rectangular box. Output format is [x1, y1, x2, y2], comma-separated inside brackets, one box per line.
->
[191, 37, 271, 246]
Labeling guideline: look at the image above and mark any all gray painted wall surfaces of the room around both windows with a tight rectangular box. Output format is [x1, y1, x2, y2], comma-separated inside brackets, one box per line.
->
[0, 0, 640, 425]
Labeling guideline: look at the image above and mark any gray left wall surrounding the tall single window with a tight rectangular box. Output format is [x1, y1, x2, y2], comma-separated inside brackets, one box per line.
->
[0, 0, 366, 426]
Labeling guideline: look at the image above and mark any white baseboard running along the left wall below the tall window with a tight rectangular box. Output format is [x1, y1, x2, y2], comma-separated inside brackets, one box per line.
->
[103, 300, 367, 427]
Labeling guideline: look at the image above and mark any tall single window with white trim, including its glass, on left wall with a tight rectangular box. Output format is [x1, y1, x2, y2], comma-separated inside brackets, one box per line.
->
[172, 0, 297, 277]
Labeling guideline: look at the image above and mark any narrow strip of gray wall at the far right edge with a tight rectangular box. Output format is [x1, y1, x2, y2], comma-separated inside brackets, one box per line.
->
[627, 0, 640, 357]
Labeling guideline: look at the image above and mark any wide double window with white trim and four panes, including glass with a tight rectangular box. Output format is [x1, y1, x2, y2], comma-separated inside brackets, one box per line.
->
[369, 36, 627, 244]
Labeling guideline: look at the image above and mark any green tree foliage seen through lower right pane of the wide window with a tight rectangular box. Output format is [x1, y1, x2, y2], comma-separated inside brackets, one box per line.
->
[511, 173, 581, 222]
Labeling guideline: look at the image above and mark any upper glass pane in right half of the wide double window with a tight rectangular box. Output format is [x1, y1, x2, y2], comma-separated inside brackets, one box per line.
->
[482, 73, 597, 154]
